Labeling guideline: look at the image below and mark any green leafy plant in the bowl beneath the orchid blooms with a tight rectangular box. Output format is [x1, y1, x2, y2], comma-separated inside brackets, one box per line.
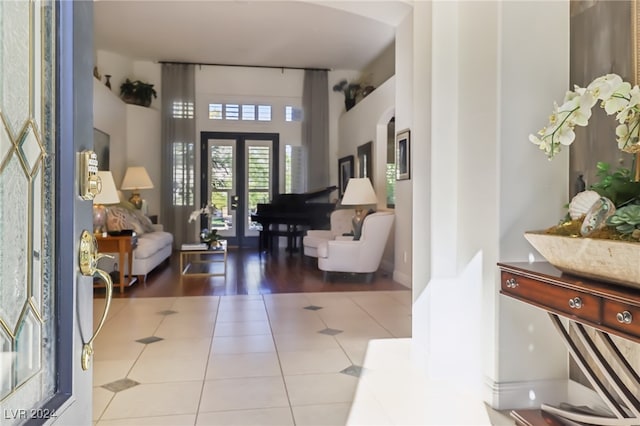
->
[591, 161, 640, 208]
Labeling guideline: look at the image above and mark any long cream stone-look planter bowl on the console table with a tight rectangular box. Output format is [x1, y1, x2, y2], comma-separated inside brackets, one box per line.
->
[524, 231, 640, 289]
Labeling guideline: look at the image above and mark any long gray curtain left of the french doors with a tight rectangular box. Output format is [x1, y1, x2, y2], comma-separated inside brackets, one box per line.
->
[161, 64, 195, 248]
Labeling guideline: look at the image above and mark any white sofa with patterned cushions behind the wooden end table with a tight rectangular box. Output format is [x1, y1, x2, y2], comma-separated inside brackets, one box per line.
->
[107, 205, 173, 283]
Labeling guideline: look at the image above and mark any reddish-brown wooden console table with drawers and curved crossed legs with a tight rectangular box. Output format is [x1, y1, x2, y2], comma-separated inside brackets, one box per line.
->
[498, 262, 640, 425]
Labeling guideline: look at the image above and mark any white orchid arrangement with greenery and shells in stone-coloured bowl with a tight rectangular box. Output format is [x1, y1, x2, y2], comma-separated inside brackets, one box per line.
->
[525, 74, 640, 288]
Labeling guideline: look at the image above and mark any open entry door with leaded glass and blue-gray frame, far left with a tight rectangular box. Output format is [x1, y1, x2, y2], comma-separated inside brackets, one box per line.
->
[0, 0, 98, 425]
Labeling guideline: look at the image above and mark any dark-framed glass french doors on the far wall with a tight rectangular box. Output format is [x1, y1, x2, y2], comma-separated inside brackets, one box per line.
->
[200, 132, 279, 247]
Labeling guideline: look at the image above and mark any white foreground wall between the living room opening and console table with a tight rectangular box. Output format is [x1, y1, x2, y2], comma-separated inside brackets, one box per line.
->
[408, 1, 569, 408]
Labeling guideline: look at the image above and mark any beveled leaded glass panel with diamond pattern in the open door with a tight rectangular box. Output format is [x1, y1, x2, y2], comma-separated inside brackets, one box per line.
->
[0, 1, 57, 416]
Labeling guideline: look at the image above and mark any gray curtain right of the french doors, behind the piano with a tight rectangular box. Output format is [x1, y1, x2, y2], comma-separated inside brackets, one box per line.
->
[302, 70, 329, 191]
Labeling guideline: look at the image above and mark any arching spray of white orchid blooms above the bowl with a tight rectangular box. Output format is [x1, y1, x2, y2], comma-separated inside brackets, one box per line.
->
[529, 74, 640, 158]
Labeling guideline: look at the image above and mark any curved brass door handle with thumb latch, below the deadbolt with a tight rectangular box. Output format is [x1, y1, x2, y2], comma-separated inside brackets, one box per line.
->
[79, 230, 113, 371]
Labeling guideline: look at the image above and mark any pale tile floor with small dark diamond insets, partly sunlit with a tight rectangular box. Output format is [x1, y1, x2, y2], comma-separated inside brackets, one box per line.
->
[93, 291, 513, 426]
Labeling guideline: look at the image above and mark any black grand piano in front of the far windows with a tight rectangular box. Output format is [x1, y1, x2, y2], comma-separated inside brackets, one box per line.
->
[251, 186, 338, 254]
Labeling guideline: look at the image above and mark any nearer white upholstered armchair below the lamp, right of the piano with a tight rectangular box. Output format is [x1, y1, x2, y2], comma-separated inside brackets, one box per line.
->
[318, 211, 394, 281]
